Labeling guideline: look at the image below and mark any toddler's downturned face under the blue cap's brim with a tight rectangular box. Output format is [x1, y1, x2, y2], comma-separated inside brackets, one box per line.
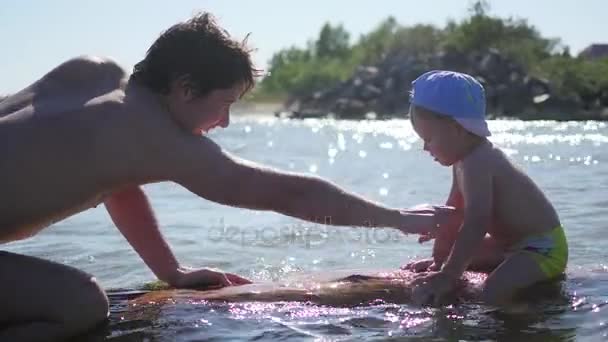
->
[410, 107, 462, 166]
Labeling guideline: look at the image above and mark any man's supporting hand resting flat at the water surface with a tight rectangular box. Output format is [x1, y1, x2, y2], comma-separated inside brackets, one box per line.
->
[172, 268, 251, 289]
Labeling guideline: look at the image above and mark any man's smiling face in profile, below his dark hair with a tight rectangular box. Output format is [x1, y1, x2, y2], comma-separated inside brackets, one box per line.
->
[168, 83, 244, 135]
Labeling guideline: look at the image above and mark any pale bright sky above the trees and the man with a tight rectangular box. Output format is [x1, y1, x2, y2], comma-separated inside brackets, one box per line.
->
[0, 0, 608, 94]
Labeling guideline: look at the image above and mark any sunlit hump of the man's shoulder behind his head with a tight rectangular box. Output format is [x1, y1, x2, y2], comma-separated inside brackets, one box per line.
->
[42, 55, 127, 87]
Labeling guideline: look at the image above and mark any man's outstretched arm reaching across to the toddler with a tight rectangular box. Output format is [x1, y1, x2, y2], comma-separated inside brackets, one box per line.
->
[173, 137, 446, 233]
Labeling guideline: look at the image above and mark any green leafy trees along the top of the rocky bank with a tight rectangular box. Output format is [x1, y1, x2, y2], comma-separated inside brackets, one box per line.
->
[256, 1, 608, 113]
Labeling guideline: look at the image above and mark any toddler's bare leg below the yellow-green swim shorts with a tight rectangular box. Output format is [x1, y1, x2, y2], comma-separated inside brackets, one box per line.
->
[481, 252, 548, 305]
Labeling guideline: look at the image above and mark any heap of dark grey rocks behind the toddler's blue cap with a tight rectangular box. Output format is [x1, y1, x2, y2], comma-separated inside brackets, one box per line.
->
[281, 49, 608, 120]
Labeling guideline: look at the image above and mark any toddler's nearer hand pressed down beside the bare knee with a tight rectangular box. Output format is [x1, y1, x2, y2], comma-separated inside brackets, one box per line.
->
[412, 271, 458, 305]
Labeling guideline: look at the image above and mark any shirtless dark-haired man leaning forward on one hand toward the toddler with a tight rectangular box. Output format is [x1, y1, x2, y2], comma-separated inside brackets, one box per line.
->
[0, 14, 449, 341]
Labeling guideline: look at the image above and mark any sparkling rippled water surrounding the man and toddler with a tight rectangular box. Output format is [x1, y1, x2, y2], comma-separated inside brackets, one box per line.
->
[3, 117, 608, 341]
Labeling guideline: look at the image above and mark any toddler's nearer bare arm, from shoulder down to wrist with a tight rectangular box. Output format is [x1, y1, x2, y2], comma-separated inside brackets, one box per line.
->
[441, 158, 493, 279]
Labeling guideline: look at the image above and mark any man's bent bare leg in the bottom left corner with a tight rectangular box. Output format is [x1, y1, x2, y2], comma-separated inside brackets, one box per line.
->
[0, 251, 108, 341]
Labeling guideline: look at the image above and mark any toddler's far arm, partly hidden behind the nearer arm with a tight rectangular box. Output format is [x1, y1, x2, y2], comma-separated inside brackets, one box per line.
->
[433, 167, 463, 269]
